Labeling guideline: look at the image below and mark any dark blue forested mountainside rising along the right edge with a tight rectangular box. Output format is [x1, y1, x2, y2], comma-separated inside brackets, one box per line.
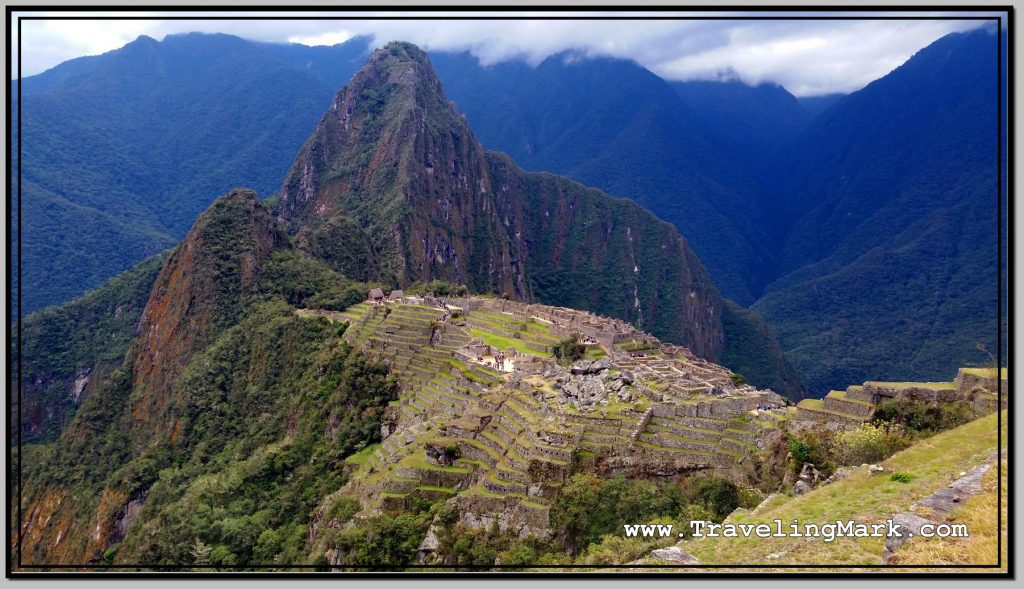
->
[754, 31, 999, 390]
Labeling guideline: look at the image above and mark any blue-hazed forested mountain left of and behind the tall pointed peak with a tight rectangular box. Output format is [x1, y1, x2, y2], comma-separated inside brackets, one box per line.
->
[14, 35, 364, 312]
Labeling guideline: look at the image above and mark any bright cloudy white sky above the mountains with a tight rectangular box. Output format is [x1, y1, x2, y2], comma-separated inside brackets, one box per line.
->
[8, 8, 999, 96]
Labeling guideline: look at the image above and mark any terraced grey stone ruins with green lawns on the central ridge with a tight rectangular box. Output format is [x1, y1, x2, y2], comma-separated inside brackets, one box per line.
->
[304, 295, 790, 536]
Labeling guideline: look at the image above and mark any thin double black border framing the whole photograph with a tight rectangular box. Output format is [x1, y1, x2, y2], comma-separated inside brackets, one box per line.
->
[5, 5, 1015, 579]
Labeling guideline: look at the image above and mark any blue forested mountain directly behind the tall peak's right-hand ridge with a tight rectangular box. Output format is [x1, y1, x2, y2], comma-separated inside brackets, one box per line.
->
[431, 53, 774, 304]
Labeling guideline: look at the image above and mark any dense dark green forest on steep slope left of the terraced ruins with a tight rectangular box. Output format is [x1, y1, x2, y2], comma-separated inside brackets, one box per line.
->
[111, 305, 396, 565]
